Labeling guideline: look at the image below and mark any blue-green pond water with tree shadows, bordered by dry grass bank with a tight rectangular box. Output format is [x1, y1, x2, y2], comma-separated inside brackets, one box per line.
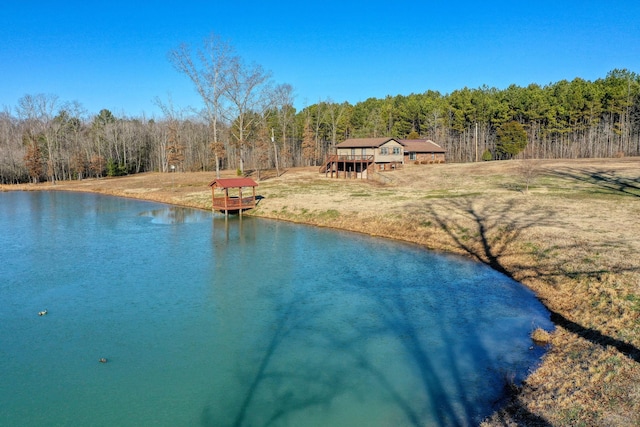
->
[0, 192, 552, 427]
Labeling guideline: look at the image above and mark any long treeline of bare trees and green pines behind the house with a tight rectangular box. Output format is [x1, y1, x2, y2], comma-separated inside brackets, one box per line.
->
[0, 70, 640, 183]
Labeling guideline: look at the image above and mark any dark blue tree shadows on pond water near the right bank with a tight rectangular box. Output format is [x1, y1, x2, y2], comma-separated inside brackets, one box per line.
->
[338, 266, 549, 426]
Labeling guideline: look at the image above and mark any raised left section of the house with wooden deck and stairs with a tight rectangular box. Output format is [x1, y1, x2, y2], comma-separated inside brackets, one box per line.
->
[320, 137, 404, 178]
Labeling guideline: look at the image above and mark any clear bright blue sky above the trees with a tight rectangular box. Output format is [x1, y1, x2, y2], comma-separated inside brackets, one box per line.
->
[0, 0, 640, 117]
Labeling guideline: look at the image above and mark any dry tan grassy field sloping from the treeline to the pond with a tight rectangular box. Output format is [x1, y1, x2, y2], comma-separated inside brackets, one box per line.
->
[0, 158, 640, 426]
